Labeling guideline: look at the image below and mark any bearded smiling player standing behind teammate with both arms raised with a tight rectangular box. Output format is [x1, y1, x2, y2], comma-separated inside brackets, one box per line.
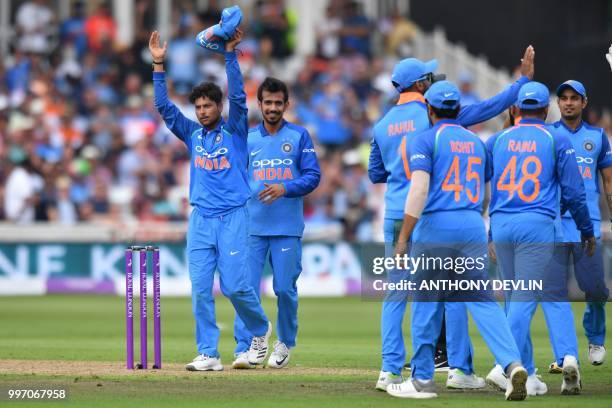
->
[232, 78, 321, 368]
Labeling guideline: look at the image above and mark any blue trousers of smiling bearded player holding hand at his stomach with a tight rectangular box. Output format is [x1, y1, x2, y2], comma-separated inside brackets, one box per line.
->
[234, 235, 302, 354]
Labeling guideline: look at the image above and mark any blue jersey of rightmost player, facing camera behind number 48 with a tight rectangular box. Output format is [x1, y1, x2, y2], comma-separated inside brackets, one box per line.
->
[552, 121, 612, 242]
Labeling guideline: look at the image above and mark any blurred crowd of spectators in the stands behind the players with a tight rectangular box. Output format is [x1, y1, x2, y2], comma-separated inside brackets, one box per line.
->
[0, 0, 612, 241]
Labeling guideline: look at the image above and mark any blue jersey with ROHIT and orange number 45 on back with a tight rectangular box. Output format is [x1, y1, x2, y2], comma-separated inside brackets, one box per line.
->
[409, 120, 492, 214]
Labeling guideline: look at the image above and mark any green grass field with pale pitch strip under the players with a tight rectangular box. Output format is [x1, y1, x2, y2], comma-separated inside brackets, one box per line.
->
[0, 296, 612, 408]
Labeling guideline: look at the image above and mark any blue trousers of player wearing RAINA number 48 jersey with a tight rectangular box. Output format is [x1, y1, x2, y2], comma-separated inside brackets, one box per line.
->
[491, 212, 578, 375]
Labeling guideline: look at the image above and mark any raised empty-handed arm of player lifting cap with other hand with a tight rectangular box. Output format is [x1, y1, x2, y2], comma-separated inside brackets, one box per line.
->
[149, 31, 200, 149]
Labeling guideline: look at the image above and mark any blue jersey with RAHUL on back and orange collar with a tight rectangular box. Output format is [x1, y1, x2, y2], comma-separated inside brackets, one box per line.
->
[368, 77, 529, 220]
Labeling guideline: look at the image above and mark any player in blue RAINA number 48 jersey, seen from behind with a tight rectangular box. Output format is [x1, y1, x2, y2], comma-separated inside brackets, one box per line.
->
[486, 82, 595, 395]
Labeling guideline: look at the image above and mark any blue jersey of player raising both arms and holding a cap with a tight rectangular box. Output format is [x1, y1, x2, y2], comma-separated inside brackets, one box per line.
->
[153, 52, 250, 217]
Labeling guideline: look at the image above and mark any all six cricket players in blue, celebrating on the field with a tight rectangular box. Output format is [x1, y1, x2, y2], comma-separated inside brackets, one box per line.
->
[149, 6, 612, 400]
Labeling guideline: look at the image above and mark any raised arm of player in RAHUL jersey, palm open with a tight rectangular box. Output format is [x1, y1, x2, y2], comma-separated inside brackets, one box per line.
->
[457, 45, 535, 126]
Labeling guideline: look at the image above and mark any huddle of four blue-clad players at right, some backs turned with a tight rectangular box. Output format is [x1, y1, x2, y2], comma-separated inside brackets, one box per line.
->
[369, 46, 612, 400]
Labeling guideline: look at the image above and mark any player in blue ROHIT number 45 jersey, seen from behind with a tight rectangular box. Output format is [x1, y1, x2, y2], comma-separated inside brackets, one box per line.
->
[387, 81, 527, 400]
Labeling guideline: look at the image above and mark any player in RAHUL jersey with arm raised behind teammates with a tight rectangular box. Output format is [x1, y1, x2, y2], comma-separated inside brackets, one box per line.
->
[368, 46, 535, 391]
